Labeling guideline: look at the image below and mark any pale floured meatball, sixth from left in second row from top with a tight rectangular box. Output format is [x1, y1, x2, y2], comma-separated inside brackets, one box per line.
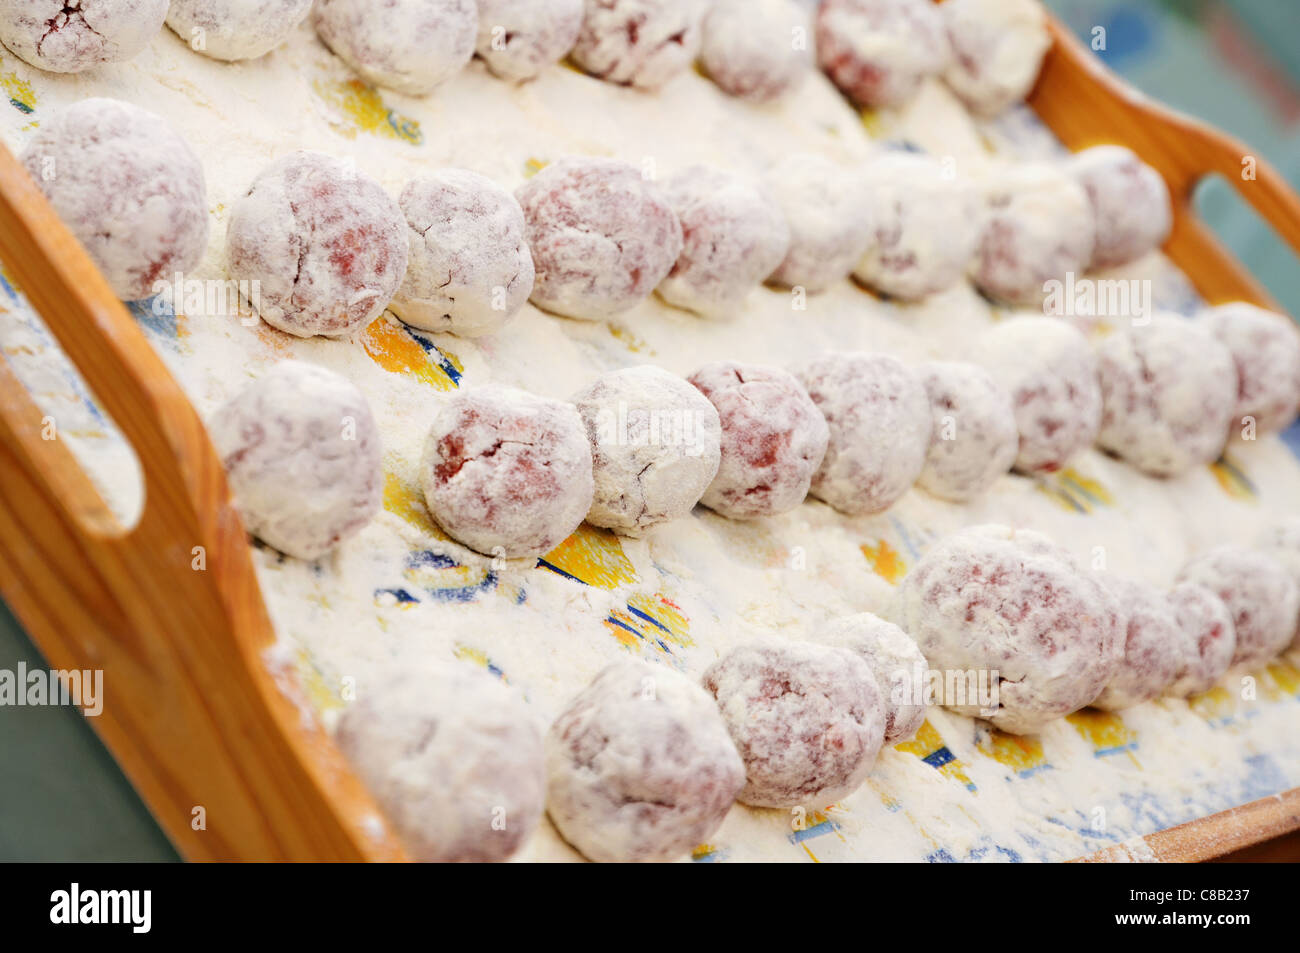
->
[766, 153, 872, 294]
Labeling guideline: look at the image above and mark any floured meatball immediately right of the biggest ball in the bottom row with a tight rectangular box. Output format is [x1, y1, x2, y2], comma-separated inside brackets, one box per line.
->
[1092, 573, 1191, 711]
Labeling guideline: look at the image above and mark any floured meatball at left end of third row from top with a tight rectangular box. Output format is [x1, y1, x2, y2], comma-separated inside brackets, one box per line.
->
[208, 360, 384, 559]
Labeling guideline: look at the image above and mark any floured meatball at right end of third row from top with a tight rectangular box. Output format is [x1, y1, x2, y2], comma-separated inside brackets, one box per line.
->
[1200, 302, 1300, 437]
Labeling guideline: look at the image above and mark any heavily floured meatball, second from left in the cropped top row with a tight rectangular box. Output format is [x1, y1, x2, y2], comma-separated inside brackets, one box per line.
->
[166, 0, 312, 60]
